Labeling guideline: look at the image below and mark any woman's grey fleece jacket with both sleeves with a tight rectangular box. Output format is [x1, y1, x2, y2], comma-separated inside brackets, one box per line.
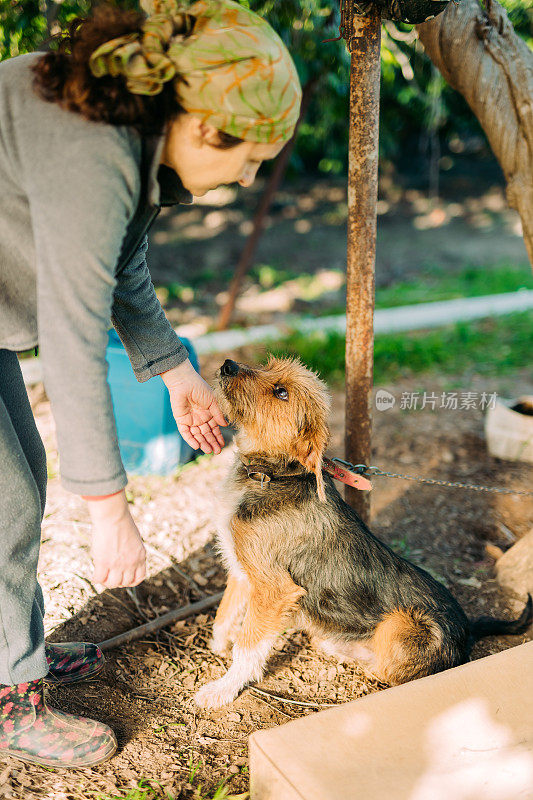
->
[0, 54, 191, 495]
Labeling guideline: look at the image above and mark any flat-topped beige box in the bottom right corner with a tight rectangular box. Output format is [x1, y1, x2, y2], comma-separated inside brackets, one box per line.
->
[250, 642, 533, 800]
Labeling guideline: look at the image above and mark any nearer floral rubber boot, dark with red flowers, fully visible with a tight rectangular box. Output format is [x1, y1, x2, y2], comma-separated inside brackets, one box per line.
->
[0, 678, 117, 768]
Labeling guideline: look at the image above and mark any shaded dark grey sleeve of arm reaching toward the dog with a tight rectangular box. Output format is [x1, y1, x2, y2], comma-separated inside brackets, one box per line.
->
[111, 237, 188, 382]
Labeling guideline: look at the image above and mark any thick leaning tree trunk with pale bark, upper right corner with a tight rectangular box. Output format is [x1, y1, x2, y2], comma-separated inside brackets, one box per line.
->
[417, 0, 533, 265]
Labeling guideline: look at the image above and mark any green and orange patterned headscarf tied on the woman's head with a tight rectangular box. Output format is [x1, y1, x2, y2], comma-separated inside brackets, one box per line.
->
[89, 0, 301, 144]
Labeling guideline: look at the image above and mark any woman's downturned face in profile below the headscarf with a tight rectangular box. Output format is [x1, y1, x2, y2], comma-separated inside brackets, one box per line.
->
[161, 114, 284, 197]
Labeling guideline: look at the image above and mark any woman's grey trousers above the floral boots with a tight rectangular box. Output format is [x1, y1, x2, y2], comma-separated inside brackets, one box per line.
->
[0, 349, 48, 685]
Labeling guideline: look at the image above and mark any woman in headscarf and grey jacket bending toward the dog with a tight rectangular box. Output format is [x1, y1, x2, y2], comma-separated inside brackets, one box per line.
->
[0, 0, 301, 767]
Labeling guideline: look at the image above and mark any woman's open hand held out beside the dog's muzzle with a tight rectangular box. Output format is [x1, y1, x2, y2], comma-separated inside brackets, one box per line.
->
[161, 360, 227, 454]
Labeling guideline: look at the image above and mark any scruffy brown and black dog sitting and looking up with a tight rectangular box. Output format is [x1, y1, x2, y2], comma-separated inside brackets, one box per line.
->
[196, 358, 532, 708]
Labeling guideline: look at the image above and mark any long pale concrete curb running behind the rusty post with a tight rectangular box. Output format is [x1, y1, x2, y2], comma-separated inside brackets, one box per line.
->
[21, 289, 533, 385]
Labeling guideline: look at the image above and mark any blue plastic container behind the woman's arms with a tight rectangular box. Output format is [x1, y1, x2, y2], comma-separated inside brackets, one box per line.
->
[106, 330, 200, 475]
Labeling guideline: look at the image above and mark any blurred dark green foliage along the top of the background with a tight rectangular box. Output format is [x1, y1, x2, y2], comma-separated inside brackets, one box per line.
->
[0, 0, 533, 174]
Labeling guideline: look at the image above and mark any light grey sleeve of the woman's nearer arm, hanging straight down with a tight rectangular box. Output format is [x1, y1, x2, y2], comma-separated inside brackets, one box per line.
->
[28, 129, 140, 495]
